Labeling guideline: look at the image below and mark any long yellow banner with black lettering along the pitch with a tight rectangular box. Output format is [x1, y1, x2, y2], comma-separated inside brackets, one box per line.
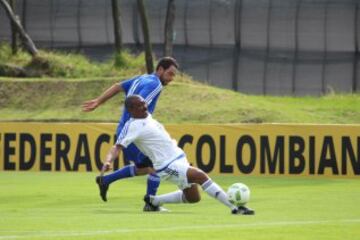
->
[0, 123, 360, 177]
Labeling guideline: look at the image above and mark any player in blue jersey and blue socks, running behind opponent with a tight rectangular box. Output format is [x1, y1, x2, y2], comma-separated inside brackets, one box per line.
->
[82, 57, 178, 211]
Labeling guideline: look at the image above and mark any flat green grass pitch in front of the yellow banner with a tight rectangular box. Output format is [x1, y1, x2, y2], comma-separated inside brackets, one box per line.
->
[0, 172, 360, 240]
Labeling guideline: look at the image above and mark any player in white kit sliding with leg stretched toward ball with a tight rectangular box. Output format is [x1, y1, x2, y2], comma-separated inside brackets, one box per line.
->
[99, 95, 255, 215]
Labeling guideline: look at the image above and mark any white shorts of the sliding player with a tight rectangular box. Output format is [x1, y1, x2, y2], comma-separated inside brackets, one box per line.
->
[157, 157, 192, 190]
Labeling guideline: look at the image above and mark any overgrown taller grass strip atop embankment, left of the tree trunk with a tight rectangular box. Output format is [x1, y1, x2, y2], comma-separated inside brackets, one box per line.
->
[0, 42, 144, 79]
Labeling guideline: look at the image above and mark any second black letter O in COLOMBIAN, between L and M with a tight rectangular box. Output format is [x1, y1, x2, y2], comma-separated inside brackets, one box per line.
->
[236, 135, 256, 174]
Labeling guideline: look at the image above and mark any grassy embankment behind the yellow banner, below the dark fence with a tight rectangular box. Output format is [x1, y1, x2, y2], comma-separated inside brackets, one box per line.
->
[0, 43, 360, 123]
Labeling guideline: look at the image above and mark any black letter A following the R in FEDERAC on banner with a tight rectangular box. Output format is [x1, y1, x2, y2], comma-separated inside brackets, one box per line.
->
[73, 133, 92, 172]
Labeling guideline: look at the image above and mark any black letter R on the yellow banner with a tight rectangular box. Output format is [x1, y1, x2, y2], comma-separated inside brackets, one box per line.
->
[55, 133, 71, 171]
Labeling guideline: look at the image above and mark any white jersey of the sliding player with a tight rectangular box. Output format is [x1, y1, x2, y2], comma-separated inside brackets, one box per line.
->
[116, 114, 184, 170]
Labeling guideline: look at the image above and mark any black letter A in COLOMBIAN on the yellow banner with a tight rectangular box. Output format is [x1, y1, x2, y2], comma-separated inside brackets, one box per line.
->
[318, 136, 339, 175]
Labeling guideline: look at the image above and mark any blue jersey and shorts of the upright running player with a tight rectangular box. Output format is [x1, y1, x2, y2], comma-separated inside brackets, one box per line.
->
[116, 74, 163, 164]
